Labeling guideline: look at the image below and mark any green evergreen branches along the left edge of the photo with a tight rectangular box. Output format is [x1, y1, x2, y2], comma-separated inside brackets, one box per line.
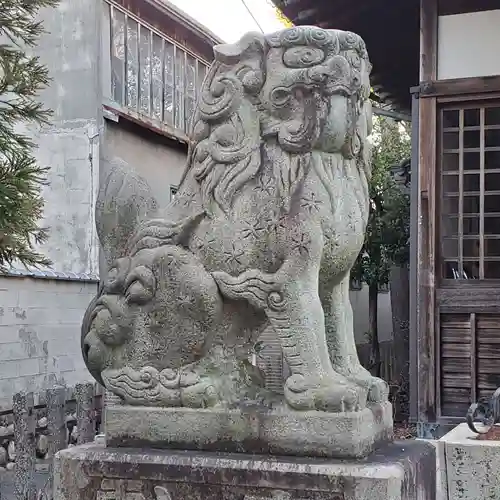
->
[0, 0, 57, 269]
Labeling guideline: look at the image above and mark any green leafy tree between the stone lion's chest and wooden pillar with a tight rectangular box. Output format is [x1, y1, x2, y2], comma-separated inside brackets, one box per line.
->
[351, 117, 411, 287]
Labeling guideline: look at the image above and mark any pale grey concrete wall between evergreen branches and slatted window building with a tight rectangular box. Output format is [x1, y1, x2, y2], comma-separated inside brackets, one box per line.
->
[29, 0, 102, 274]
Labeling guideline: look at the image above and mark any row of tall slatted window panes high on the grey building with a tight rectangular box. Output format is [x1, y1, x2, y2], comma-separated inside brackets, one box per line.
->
[106, 3, 208, 133]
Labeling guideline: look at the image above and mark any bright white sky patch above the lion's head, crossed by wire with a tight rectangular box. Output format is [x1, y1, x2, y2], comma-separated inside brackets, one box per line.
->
[170, 0, 283, 43]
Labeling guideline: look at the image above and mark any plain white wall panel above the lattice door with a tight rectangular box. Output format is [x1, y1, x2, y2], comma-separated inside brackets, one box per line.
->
[438, 9, 500, 80]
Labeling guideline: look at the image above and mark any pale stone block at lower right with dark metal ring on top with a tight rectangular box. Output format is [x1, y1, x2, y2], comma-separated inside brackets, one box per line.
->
[438, 424, 500, 500]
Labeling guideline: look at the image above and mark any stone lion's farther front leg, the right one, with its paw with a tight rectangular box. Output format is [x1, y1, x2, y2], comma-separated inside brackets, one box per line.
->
[320, 275, 389, 403]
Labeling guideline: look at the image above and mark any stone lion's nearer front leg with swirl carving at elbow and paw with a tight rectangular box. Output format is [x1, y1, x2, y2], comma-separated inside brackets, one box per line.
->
[213, 263, 366, 412]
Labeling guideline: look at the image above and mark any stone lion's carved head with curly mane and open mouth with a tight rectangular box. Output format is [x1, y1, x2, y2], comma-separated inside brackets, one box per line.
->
[189, 26, 371, 211]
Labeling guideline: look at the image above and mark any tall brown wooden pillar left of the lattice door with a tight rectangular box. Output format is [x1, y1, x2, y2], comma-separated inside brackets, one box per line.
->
[416, 0, 438, 430]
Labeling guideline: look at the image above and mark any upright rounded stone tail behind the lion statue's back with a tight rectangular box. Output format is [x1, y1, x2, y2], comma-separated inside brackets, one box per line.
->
[96, 160, 158, 265]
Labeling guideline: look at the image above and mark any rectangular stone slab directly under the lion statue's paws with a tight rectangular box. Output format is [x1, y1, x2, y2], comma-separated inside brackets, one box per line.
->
[105, 403, 392, 458]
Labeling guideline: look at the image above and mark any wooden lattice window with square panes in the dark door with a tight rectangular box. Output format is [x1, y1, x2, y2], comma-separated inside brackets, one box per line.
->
[439, 103, 500, 280]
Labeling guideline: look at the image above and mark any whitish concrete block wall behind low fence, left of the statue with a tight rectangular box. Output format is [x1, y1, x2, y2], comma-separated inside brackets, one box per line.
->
[0, 276, 97, 411]
